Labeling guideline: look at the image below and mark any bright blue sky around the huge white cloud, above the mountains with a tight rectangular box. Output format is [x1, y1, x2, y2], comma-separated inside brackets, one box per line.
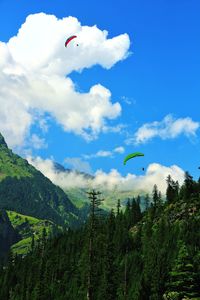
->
[0, 0, 200, 191]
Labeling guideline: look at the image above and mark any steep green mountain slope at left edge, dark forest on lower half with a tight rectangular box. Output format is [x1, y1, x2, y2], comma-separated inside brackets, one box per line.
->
[0, 134, 79, 226]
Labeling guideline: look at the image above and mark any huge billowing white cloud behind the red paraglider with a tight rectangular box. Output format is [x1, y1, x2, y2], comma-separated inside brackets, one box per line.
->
[0, 13, 130, 146]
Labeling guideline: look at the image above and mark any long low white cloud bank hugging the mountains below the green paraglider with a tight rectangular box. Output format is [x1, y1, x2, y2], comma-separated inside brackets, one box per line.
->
[28, 157, 184, 194]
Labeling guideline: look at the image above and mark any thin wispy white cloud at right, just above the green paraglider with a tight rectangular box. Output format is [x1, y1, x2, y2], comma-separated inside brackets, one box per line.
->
[127, 115, 200, 144]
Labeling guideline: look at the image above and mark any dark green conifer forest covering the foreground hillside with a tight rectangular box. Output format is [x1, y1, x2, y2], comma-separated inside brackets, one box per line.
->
[0, 173, 200, 300]
